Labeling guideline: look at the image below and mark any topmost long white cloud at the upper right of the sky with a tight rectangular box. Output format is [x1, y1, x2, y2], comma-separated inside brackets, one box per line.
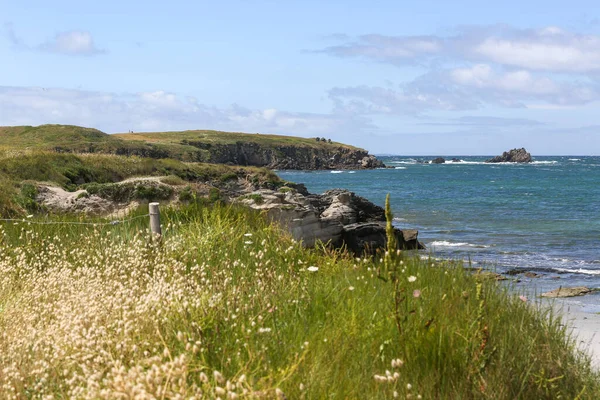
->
[322, 25, 600, 73]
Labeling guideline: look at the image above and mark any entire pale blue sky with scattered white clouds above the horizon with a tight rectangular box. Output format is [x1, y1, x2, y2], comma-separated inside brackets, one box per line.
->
[0, 0, 600, 155]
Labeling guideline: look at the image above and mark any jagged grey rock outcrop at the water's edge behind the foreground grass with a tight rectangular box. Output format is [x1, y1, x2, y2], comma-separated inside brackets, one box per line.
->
[237, 189, 425, 255]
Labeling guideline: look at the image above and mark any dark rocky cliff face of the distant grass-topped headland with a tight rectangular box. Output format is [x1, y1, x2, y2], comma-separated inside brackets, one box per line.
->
[182, 141, 385, 170]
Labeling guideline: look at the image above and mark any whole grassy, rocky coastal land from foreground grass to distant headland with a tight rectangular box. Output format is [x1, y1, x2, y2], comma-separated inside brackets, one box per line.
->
[0, 126, 600, 399]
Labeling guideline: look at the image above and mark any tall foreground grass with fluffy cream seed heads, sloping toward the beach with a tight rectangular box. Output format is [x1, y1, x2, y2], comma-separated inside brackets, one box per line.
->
[0, 204, 600, 399]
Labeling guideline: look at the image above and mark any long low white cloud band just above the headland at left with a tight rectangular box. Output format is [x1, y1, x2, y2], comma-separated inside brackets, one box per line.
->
[0, 86, 373, 139]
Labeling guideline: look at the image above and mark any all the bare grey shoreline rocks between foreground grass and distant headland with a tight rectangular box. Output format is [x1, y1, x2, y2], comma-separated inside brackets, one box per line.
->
[37, 177, 425, 256]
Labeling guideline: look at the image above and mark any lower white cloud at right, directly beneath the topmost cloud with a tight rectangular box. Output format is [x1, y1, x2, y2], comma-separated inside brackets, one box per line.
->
[329, 64, 600, 115]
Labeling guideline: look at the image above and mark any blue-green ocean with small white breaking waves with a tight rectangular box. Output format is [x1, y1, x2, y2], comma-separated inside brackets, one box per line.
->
[278, 156, 600, 311]
